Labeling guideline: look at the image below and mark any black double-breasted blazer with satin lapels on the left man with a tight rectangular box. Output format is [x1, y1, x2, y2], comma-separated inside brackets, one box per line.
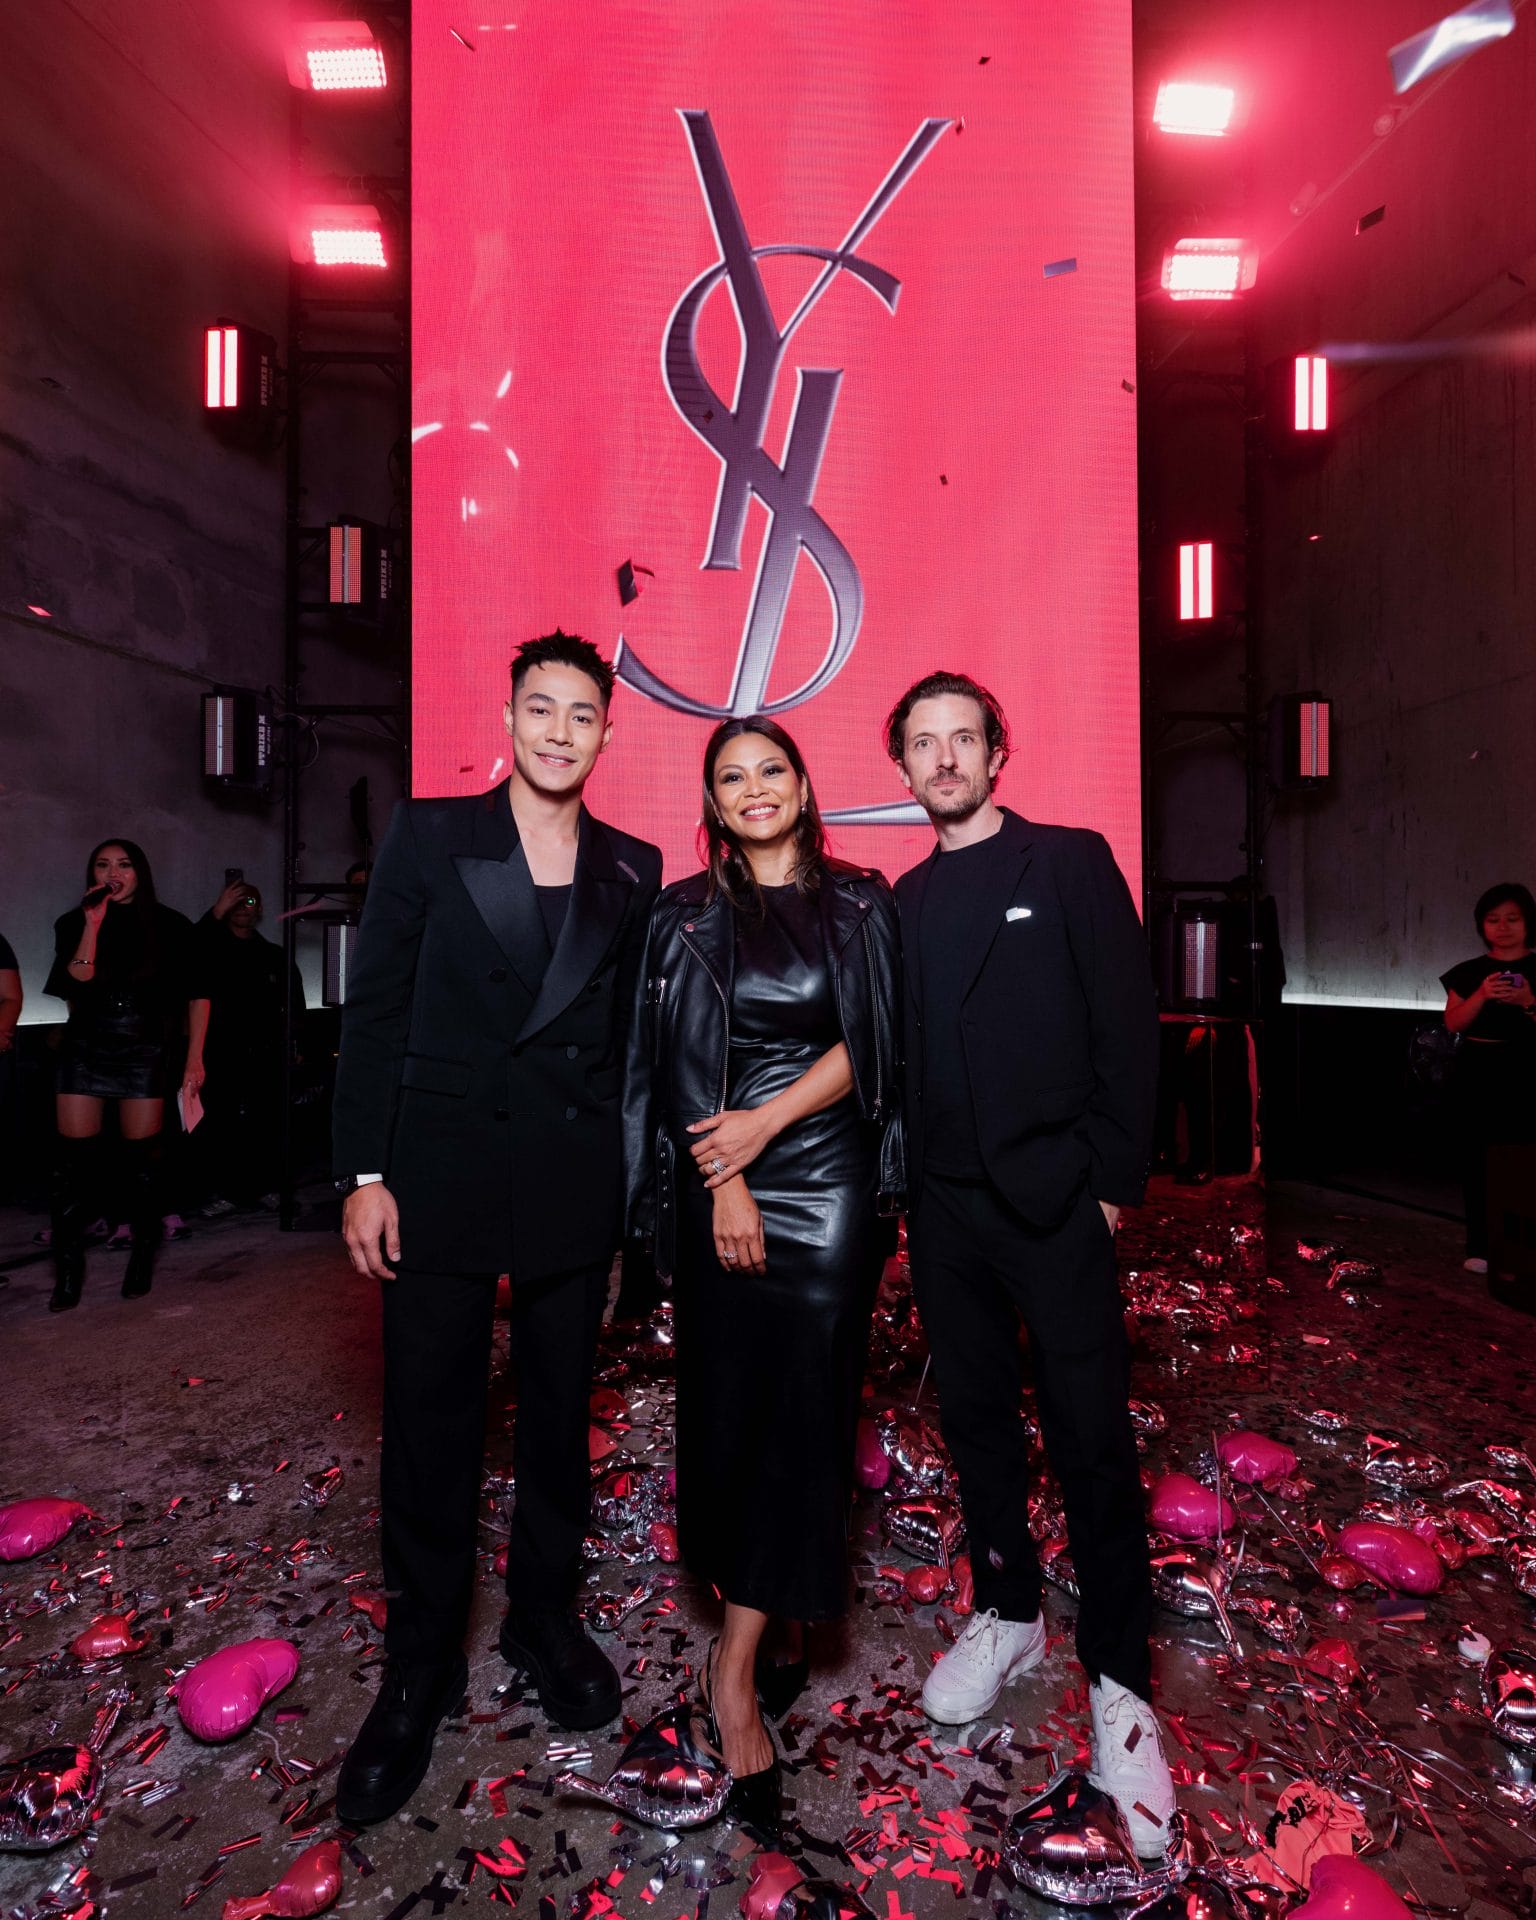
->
[332, 785, 660, 1279]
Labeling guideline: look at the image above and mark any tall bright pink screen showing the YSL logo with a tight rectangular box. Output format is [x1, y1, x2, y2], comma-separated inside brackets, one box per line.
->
[413, 0, 1140, 889]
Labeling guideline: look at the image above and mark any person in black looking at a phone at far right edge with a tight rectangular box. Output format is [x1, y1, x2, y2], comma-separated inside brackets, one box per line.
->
[1440, 881, 1536, 1273]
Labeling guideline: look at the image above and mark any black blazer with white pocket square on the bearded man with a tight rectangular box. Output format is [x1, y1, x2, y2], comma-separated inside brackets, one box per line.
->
[897, 808, 1158, 1227]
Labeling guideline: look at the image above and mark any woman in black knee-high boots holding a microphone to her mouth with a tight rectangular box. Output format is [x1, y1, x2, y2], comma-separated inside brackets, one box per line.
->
[44, 839, 207, 1313]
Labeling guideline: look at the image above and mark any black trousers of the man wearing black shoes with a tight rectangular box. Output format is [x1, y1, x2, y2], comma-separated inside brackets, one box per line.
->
[380, 1265, 609, 1665]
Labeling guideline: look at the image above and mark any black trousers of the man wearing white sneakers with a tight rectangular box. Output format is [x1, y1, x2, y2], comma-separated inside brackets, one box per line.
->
[908, 1177, 1152, 1699]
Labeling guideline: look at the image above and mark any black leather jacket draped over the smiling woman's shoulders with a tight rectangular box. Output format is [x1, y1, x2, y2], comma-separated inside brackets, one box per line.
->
[624, 862, 906, 1275]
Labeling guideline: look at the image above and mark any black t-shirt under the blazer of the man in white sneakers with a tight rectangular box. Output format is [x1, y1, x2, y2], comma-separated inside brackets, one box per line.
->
[918, 833, 1002, 1181]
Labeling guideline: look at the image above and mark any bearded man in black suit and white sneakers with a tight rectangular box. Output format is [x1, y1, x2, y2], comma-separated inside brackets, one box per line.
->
[887, 674, 1173, 1855]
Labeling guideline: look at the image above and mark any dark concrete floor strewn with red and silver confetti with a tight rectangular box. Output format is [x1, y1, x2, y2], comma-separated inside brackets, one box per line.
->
[0, 1183, 1536, 1920]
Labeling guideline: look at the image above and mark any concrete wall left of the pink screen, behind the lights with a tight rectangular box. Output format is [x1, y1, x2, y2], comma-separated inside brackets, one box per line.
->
[0, 0, 405, 1021]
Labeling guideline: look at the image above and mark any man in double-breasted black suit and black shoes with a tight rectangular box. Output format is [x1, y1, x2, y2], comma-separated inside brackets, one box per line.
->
[334, 632, 660, 1824]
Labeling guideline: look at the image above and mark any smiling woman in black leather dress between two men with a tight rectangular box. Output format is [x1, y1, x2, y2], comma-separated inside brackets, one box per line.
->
[626, 716, 902, 1824]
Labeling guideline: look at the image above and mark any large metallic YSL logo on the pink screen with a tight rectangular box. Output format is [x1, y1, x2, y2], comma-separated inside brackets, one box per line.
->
[616, 111, 950, 720]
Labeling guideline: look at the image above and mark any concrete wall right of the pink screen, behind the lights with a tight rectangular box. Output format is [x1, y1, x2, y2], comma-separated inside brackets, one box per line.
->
[1252, 0, 1536, 1004]
